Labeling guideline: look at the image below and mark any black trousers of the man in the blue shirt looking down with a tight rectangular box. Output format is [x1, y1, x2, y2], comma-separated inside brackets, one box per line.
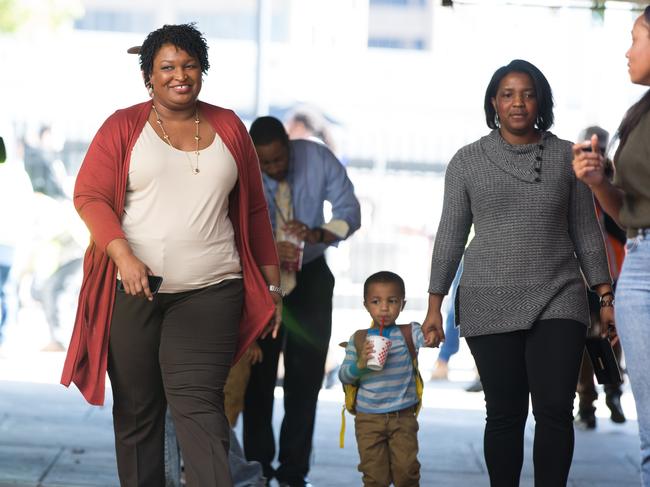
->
[244, 257, 334, 483]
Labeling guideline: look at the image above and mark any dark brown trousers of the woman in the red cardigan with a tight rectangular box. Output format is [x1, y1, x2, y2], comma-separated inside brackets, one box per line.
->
[108, 279, 243, 487]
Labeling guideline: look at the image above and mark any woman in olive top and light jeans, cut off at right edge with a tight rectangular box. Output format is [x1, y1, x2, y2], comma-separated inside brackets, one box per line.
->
[573, 6, 650, 487]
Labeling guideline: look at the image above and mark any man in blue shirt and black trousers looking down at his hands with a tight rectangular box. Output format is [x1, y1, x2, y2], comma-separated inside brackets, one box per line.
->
[244, 117, 361, 487]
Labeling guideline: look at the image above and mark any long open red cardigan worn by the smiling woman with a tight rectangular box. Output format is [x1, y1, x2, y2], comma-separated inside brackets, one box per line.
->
[61, 101, 278, 405]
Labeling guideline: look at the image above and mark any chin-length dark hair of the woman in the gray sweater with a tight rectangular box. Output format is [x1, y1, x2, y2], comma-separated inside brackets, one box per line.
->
[483, 59, 554, 130]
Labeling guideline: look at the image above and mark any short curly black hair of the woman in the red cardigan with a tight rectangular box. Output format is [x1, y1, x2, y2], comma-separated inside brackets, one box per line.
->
[140, 22, 210, 86]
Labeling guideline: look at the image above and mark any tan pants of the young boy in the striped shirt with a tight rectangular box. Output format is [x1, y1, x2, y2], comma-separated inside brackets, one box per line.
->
[354, 407, 420, 487]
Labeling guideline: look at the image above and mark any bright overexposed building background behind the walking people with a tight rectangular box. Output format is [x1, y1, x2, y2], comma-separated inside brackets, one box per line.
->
[0, 0, 643, 341]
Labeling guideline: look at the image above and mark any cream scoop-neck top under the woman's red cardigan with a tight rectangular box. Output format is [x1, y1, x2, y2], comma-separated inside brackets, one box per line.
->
[122, 123, 242, 293]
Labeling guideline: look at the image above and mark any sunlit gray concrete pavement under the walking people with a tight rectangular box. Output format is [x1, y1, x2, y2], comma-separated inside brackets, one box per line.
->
[0, 353, 640, 487]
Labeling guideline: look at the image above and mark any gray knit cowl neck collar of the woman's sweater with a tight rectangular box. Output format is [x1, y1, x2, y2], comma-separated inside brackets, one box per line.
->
[479, 129, 555, 183]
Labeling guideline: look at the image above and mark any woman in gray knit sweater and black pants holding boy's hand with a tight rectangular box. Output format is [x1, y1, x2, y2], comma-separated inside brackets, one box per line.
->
[423, 60, 615, 487]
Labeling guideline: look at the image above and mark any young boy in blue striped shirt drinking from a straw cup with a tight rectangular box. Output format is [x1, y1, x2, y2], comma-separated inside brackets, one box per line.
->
[339, 271, 424, 487]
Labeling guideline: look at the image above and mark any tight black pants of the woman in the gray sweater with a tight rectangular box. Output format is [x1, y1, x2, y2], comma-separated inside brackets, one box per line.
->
[467, 320, 587, 487]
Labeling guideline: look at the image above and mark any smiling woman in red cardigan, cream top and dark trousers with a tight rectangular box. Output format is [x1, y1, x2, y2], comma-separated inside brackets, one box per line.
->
[61, 24, 282, 487]
